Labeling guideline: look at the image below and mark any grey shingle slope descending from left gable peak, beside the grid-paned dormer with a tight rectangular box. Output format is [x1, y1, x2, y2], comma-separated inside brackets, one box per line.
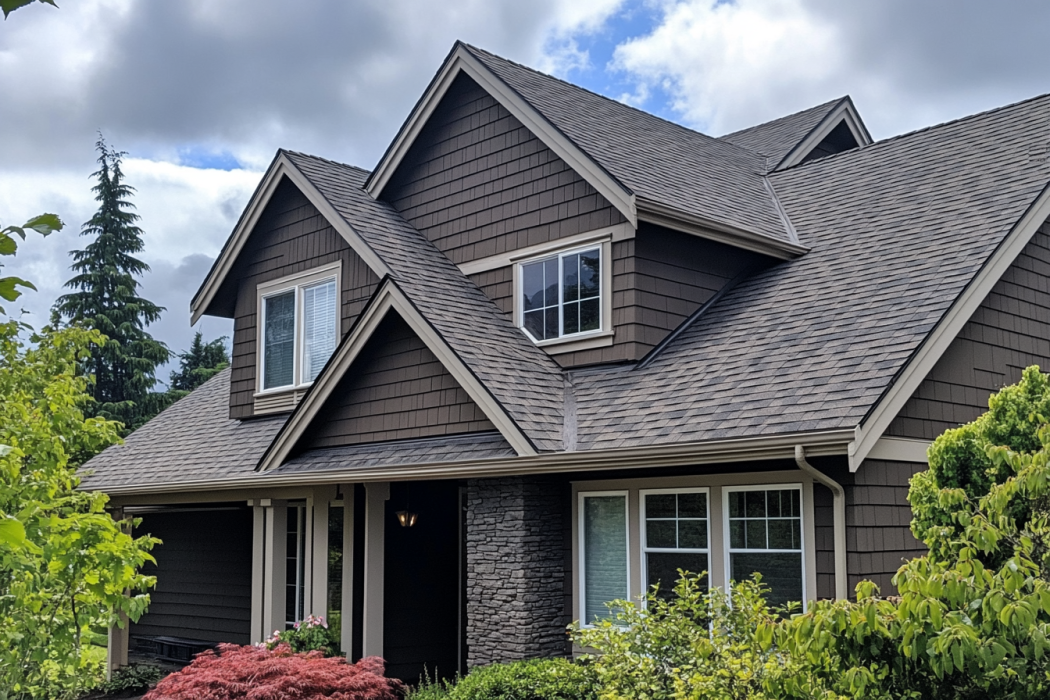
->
[286, 151, 564, 451]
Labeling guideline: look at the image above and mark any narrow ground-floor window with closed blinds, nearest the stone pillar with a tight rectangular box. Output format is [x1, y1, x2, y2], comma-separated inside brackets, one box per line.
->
[579, 491, 631, 625]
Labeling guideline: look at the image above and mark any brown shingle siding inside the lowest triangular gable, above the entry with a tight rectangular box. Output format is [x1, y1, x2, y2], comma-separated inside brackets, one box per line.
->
[301, 312, 496, 449]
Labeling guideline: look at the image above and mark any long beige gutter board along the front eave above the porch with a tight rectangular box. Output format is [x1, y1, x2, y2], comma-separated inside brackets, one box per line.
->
[96, 430, 854, 495]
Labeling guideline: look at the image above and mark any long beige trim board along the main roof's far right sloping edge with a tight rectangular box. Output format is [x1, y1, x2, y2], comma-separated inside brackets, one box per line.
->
[849, 185, 1050, 471]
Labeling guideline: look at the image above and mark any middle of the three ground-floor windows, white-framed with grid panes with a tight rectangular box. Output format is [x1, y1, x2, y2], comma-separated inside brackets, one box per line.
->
[638, 488, 711, 598]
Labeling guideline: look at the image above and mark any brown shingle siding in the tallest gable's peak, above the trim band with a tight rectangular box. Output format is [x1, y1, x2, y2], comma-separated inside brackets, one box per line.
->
[382, 75, 626, 264]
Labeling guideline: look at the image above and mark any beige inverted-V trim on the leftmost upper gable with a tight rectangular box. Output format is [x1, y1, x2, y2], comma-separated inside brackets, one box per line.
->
[190, 153, 391, 325]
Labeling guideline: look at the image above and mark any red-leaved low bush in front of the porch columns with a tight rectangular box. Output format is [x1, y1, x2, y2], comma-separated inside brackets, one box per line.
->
[144, 644, 403, 700]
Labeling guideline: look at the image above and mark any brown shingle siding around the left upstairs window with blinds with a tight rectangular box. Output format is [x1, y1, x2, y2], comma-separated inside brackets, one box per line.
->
[230, 181, 379, 419]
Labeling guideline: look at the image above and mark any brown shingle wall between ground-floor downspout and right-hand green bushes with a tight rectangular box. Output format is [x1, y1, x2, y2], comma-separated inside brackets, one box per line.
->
[844, 460, 926, 595]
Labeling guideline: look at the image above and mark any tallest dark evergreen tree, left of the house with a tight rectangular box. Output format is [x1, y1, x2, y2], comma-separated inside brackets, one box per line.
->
[56, 134, 171, 432]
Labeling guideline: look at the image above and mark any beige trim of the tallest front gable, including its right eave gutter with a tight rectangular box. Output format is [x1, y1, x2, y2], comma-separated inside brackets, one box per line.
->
[364, 42, 806, 265]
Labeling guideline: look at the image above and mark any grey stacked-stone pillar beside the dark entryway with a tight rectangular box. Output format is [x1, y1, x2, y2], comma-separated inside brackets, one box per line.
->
[466, 476, 571, 666]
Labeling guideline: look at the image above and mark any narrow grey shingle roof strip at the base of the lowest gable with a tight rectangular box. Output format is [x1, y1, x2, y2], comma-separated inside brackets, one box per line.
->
[267, 432, 516, 475]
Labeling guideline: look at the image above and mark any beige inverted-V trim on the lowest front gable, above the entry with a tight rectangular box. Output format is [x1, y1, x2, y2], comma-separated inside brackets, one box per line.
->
[256, 276, 537, 472]
